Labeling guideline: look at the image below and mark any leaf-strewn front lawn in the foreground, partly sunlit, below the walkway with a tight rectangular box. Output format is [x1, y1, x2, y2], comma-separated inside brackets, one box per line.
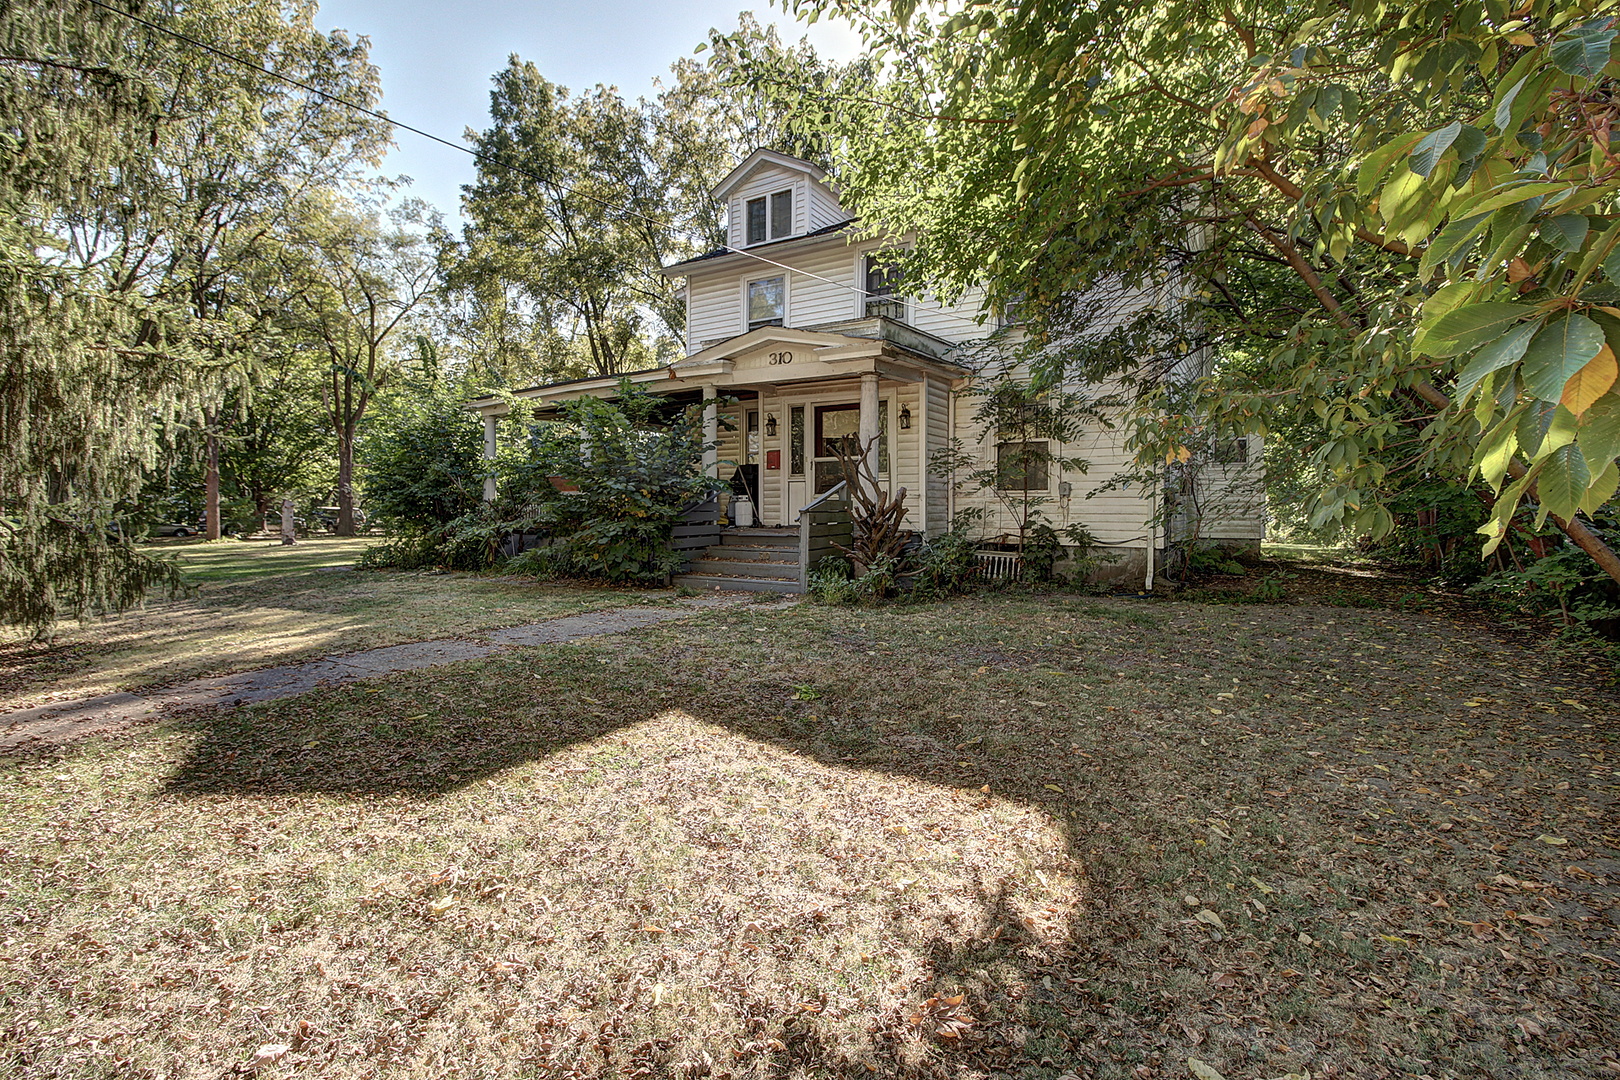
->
[0, 596, 1620, 1080]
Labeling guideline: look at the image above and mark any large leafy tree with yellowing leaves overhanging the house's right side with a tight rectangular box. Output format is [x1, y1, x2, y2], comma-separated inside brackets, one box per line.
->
[732, 0, 1620, 578]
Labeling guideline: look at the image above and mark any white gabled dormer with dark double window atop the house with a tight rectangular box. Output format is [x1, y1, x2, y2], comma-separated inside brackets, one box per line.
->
[714, 149, 847, 248]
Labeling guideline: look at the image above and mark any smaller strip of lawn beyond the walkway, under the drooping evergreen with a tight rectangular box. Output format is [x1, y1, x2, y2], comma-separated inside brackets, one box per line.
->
[0, 538, 642, 711]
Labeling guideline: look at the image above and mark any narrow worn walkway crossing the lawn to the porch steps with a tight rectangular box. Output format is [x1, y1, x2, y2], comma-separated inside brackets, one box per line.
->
[0, 593, 771, 751]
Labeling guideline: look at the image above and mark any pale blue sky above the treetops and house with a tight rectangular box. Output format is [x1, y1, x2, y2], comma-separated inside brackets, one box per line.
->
[316, 0, 860, 223]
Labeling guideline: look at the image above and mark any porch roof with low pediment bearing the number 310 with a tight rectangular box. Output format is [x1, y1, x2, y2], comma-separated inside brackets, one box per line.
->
[467, 317, 969, 416]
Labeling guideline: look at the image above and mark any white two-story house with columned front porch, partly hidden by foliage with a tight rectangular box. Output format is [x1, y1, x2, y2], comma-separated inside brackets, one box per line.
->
[470, 149, 1260, 592]
